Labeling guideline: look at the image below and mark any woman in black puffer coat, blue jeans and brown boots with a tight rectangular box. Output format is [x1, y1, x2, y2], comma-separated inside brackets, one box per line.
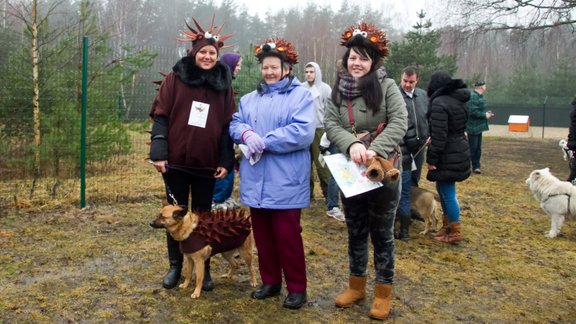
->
[426, 71, 470, 244]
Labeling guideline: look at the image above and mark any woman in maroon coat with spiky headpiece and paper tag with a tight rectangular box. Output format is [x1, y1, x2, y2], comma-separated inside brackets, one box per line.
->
[150, 19, 236, 290]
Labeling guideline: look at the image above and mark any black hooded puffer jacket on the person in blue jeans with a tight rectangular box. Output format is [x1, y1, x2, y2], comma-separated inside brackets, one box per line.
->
[426, 75, 471, 181]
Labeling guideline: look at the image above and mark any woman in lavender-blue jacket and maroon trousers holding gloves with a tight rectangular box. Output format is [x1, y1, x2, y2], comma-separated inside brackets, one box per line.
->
[230, 38, 316, 309]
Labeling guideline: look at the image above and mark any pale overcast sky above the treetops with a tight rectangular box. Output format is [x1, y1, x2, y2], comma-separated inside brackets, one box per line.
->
[227, 0, 433, 31]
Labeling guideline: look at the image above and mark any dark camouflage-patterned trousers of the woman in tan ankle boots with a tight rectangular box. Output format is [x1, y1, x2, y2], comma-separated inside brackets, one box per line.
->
[342, 181, 400, 284]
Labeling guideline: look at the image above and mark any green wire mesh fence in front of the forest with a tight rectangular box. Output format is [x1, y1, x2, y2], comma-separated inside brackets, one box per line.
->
[0, 37, 569, 206]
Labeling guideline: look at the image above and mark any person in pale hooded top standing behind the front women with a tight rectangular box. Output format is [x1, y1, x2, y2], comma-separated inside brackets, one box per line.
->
[302, 62, 332, 198]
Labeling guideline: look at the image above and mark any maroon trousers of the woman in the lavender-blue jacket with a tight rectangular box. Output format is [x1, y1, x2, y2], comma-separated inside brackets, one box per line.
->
[250, 208, 306, 293]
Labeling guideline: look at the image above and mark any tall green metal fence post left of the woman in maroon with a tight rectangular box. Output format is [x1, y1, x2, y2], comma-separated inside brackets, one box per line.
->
[80, 36, 88, 208]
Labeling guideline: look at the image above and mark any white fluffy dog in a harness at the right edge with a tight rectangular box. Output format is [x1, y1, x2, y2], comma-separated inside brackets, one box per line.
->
[526, 168, 576, 238]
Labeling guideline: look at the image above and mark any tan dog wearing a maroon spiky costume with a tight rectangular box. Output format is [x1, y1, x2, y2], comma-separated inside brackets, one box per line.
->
[153, 205, 257, 298]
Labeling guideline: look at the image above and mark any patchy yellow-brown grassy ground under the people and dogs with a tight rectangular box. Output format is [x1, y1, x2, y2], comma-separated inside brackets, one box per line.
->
[0, 138, 576, 323]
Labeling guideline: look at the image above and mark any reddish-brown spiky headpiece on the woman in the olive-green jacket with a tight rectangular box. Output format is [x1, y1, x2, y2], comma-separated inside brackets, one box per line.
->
[340, 22, 390, 58]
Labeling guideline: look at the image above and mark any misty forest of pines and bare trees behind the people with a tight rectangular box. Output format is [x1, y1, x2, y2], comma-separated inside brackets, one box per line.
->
[0, 0, 576, 198]
